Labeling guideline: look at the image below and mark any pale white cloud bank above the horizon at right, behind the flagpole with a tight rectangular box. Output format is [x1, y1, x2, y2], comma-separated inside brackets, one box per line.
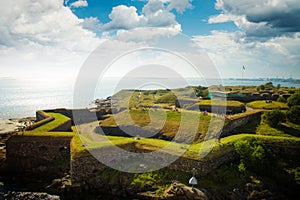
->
[194, 31, 300, 77]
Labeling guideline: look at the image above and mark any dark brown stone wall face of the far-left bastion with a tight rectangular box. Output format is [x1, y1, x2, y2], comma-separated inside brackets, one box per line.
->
[5, 135, 71, 178]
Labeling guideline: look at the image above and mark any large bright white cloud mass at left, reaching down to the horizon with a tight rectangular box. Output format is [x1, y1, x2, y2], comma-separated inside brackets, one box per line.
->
[0, 0, 101, 77]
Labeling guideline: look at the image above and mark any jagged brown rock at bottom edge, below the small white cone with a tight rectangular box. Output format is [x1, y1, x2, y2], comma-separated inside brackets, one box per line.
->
[164, 183, 208, 200]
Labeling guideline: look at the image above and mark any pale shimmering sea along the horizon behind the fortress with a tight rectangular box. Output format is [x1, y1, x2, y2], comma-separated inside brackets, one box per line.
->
[0, 77, 300, 120]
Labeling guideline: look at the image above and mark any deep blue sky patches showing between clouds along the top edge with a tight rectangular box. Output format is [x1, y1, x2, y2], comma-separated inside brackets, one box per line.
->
[64, 0, 237, 36]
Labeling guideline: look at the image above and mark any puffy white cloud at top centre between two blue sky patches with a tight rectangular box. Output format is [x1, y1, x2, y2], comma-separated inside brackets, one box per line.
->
[102, 0, 192, 32]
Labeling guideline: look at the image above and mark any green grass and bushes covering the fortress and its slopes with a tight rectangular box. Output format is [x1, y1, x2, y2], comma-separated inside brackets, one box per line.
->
[18, 83, 300, 197]
